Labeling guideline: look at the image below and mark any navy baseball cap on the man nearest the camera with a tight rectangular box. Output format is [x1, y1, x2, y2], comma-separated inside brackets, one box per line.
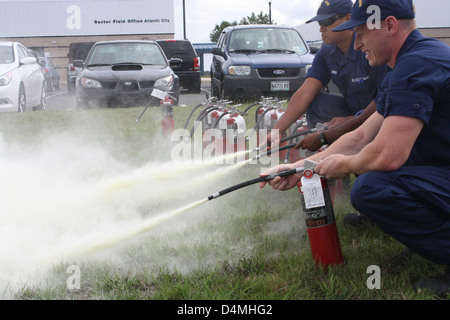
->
[333, 0, 416, 31]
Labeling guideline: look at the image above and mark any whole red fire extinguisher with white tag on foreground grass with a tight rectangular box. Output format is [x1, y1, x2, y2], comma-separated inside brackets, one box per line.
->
[298, 160, 344, 269]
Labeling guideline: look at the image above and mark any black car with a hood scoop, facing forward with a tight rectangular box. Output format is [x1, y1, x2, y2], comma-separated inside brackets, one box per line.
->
[74, 40, 179, 108]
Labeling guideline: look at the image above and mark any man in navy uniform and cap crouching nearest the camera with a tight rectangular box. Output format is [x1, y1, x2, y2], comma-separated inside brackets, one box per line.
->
[262, 0, 450, 295]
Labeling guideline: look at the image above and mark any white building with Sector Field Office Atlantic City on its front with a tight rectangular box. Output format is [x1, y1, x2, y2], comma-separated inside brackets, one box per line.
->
[0, 0, 175, 82]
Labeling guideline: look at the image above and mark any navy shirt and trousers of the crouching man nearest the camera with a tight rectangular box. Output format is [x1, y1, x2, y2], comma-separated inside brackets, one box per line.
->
[351, 30, 450, 265]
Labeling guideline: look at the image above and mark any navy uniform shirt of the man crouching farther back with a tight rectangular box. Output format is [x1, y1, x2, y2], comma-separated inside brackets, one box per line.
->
[307, 34, 387, 114]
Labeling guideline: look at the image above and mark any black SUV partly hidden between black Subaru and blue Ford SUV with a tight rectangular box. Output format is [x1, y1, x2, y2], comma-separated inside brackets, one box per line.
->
[156, 40, 201, 93]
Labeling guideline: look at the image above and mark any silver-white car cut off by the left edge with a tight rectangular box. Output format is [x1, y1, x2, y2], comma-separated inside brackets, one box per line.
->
[0, 41, 46, 112]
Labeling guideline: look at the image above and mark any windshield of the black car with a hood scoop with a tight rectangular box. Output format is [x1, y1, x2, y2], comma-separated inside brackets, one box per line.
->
[88, 43, 167, 67]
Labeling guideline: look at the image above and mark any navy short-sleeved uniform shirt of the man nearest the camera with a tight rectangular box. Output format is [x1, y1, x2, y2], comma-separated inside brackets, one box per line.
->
[375, 30, 450, 168]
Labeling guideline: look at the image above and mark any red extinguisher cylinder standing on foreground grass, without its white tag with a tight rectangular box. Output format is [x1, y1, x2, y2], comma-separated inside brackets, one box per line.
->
[298, 172, 344, 268]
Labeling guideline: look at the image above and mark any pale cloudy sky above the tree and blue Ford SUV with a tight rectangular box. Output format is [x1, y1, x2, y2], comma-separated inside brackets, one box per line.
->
[174, 0, 322, 43]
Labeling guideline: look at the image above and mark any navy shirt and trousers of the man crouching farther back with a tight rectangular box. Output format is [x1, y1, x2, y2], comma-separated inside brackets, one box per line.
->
[306, 35, 387, 128]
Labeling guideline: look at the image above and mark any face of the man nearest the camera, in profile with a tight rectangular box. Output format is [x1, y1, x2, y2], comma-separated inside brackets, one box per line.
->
[355, 23, 390, 67]
